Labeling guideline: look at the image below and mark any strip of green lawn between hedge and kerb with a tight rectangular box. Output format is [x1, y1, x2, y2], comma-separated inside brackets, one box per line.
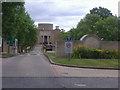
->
[47, 53, 118, 68]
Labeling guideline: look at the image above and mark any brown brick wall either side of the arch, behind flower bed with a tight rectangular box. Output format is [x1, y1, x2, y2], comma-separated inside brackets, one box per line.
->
[56, 40, 120, 57]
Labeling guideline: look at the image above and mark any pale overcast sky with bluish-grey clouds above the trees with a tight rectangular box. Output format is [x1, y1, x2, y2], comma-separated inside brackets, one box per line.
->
[25, 0, 119, 31]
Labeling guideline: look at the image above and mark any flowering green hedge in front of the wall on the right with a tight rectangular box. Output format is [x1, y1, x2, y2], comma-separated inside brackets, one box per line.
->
[71, 45, 118, 59]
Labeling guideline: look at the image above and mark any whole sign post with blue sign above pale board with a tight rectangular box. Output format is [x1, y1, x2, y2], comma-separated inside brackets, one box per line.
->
[65, 37, 73, 60]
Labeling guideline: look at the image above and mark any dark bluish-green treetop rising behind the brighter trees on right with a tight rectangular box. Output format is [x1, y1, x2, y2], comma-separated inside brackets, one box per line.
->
[90, 7, 113, 19]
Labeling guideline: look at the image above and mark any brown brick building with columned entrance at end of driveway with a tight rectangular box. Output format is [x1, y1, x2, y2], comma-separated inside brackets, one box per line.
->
[38, 23, 60, 45]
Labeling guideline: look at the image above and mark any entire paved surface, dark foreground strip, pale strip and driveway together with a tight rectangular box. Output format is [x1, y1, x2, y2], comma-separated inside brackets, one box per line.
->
[2, 46, 118, 88]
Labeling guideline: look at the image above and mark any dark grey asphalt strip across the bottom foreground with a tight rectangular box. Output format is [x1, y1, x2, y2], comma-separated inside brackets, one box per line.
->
[2, 77, 118, 88]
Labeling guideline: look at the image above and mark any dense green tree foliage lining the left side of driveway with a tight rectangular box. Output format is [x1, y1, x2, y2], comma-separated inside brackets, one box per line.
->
[2, 2, 37, 52]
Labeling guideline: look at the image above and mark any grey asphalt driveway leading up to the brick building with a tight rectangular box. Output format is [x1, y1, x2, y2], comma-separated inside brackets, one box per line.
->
[2, 47, 54, 77]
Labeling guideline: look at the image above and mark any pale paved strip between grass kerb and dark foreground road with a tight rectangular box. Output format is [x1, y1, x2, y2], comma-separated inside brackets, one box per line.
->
[52, 65, 118, 77]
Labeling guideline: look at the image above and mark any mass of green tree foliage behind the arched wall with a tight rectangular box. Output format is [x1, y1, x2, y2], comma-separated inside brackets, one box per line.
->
[62, 7, 120, 41]
